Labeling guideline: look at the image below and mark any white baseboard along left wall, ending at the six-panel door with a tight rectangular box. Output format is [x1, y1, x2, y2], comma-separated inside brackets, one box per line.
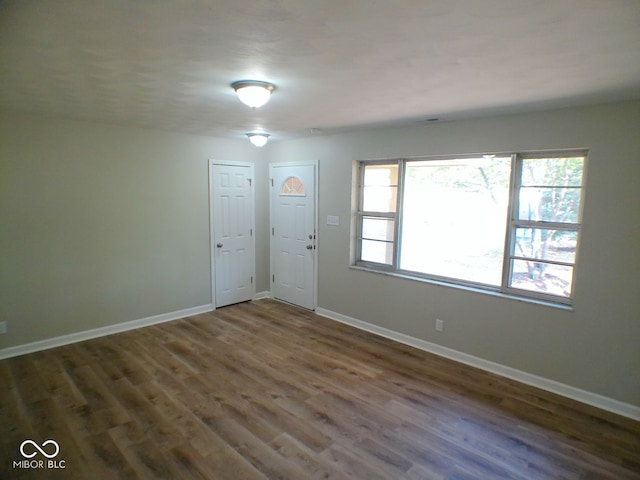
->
[0, 304, 213, 360]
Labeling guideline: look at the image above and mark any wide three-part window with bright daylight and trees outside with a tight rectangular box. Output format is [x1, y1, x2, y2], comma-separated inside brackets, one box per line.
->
[356, 152, 586, 304]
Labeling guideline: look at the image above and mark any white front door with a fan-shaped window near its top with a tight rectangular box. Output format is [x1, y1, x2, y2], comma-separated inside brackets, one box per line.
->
[270, 163, 317, 310]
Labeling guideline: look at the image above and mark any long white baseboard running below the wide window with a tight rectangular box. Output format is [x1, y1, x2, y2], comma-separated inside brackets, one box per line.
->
[316, 307, 640, 420]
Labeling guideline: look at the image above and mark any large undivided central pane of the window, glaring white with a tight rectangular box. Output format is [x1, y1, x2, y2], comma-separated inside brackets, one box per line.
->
[400, 157, 511, 286]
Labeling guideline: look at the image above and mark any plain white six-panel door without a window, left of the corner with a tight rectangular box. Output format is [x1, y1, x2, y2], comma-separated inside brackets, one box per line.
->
[209, 161, 255, 308]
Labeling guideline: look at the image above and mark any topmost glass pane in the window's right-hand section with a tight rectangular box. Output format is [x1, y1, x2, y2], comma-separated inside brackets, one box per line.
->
[520, 157, 584, 187]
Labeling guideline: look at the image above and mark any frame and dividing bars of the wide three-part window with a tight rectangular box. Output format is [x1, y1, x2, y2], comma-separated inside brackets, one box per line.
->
[352, 149, 588, 307]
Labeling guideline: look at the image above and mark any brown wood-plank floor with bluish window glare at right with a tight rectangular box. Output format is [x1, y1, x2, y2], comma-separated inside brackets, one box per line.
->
[0, 300, 640, 480]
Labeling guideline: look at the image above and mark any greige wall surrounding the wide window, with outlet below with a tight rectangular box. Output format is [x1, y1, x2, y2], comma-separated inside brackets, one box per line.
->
[267, 102, 640, 406]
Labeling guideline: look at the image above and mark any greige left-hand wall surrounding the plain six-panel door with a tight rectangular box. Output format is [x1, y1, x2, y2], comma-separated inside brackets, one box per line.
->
[0, 115, 269, 348]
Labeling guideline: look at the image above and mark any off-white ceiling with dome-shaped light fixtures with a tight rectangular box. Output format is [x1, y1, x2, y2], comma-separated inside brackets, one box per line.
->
[0, 0, 640, 140]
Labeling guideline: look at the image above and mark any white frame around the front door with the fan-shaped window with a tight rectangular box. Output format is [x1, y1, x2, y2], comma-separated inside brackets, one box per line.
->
[269, 160, 320, 311]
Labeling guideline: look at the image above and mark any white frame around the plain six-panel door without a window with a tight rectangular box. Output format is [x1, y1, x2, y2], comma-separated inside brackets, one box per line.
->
[208, 158, 256, 310]
